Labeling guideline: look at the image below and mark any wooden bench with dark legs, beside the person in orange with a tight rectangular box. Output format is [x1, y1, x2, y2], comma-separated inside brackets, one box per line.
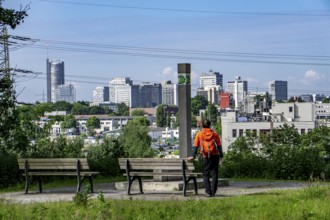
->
[118, 158, 202, 196]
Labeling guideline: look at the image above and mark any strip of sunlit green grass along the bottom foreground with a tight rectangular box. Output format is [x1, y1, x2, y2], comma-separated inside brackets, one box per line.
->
[0, 184, 330, 220]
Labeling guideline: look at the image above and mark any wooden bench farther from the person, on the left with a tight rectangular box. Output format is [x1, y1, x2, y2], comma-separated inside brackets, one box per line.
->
[18, 158, 98, 194]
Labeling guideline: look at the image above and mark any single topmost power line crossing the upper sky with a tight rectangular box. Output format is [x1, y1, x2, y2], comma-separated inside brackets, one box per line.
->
[37, 0, 330, 17]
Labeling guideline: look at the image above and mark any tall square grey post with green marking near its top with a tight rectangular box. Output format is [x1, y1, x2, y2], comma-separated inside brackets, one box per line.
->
[178, 63, 192, 158]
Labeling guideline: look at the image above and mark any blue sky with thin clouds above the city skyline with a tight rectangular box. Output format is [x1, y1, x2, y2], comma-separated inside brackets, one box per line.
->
[3, 0, 330, 103]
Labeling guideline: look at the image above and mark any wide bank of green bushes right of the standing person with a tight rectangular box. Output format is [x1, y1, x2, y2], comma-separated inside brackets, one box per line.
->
[221, 125, 329, 180]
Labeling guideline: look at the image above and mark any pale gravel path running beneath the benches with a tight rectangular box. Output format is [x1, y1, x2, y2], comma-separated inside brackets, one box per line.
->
[0, 181, 320, 204]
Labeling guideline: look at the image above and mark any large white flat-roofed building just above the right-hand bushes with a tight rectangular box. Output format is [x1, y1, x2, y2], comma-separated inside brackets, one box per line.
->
[221, 102, 317, 152]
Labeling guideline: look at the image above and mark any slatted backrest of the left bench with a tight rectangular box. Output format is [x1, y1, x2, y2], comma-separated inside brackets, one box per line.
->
[17, 158, 89, 170]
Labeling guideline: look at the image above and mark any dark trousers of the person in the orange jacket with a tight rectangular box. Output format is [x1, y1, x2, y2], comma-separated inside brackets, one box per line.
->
[203, 155, 219, 195]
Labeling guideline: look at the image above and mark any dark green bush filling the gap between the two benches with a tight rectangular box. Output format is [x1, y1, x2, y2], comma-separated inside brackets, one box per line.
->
[87, 137, 125, 176]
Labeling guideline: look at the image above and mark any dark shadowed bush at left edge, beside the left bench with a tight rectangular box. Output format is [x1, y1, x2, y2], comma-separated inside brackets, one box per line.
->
[0, 153, 21, 188]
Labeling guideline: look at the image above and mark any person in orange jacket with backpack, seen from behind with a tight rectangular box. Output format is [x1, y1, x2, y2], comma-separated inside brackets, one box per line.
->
[187, 119, 223, 197]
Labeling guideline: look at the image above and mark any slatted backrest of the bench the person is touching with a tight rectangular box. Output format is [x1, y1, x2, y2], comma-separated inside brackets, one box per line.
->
[118, 158, 195, 171]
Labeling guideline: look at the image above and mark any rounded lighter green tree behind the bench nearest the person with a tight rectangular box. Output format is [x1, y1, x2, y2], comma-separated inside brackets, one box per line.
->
[119, 121, 155, 157]
